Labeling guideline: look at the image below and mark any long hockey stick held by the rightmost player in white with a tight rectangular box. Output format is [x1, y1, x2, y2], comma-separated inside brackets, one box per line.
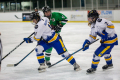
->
[40, 39, 99, 68]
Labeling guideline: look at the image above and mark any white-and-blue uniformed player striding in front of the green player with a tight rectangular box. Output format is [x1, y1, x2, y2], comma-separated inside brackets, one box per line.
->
[24, 13, 80, 72]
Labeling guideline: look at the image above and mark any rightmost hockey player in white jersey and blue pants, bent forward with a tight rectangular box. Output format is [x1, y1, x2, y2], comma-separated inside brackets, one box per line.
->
[83, 10, 118, 73]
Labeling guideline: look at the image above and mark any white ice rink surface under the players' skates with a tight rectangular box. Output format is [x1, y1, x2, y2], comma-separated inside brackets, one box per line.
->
[0, 23, 120, 80]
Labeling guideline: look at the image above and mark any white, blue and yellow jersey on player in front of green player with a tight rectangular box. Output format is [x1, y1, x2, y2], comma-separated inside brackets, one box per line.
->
[31, 17, 58, 43]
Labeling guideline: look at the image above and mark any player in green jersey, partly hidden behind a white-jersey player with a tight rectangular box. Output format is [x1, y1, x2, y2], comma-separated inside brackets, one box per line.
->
[42, 6, 68, 66]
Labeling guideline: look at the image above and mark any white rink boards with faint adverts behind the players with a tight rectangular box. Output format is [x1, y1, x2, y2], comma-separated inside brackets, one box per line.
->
[0, 10, 120, 21]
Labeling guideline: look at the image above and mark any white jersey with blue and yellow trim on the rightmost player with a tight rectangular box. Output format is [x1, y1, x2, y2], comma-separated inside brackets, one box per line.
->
[88, 18, 118, 45]
